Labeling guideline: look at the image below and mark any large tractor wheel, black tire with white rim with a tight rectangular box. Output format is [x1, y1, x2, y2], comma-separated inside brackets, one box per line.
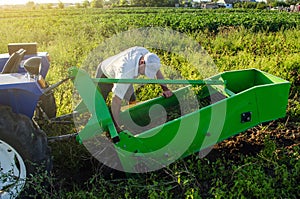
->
[0, 105, 52, 198]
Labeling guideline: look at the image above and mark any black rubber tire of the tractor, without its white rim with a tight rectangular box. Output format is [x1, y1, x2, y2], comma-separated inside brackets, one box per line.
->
[0, 105, 52, 173]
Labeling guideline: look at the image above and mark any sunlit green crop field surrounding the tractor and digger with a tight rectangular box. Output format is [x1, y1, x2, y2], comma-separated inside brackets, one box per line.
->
[0, 8, 300, 198]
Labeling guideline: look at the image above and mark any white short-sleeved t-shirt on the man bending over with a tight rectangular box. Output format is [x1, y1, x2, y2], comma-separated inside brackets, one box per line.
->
[101, 46, 149, 99]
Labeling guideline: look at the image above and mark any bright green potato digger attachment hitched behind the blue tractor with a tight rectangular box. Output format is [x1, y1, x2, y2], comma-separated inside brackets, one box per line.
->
[69, 67, 290, 173]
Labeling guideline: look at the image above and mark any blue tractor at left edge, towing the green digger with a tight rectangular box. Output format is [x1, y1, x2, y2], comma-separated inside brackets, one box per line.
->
[0, 43, 56, 198]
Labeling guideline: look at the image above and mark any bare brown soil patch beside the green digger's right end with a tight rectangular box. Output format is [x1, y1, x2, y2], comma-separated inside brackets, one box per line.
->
[207, 119, 300, 160]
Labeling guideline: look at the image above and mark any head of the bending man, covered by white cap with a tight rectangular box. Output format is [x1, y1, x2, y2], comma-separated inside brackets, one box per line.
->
[144, 53, 161, 79]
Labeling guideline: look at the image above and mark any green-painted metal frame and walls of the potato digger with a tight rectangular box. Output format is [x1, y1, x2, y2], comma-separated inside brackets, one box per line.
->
[70, 68, 290, 172]
